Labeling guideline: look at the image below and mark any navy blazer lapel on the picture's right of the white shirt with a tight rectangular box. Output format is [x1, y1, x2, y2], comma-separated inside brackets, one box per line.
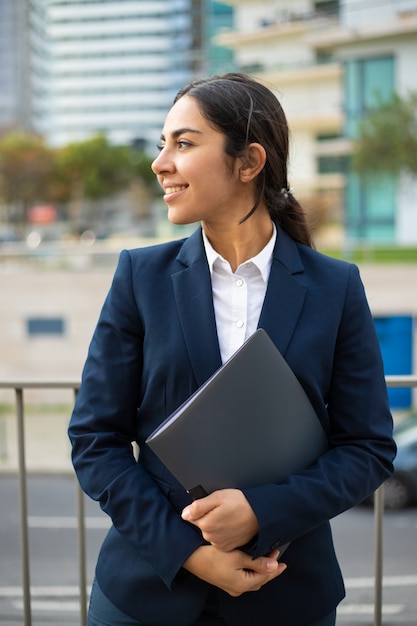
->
[258, 226, 307, 354]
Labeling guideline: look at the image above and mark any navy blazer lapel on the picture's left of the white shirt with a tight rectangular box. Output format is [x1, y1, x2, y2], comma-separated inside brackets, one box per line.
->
[171, 229, 221, 386]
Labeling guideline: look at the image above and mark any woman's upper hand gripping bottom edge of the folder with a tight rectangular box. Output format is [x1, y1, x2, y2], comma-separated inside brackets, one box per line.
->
[181, 489, 259, 552]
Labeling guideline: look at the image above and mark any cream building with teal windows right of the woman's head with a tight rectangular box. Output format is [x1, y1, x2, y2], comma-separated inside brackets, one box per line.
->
[216, 0, 417, 244]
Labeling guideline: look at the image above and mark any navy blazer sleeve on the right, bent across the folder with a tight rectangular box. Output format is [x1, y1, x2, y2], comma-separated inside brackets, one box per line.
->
[244, 265, 396, 556]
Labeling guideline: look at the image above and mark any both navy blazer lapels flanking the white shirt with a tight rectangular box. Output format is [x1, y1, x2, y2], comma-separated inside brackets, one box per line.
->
[172, 222, 307, 386]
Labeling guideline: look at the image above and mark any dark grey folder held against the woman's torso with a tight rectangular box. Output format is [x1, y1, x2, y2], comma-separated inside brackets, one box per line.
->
[147, 329, 328, 498]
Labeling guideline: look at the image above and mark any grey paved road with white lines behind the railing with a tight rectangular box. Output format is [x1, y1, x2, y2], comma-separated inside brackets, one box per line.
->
[0, 475, 417, 626]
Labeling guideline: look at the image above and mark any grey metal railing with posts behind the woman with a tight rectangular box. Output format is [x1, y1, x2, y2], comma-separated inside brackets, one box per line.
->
[0, 375, 417, 626]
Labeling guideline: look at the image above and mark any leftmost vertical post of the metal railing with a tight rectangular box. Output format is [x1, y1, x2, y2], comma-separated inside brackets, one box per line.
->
[15, 387, 32, 626]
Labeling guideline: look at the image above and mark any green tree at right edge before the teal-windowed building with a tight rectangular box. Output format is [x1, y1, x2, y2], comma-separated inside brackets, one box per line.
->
[352, 92, 417, 176]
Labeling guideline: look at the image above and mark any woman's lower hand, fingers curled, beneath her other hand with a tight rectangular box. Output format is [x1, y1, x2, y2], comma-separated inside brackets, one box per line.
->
[183, 545, 287, 597]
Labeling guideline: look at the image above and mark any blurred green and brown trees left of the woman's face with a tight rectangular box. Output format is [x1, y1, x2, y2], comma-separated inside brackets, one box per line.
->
[0, 132, 155, 220]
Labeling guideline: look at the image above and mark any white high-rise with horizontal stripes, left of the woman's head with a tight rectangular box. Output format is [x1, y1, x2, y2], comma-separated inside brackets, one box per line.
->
[47, 0, 202, 144]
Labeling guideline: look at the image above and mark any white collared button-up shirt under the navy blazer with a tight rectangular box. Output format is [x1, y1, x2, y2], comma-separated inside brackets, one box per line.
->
[203, 224, 277, 363]
